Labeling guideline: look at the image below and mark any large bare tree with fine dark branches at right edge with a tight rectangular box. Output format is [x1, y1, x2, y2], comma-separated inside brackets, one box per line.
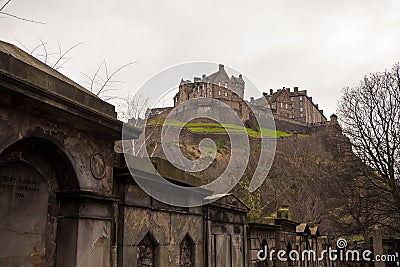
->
[339, 63, 400, 230]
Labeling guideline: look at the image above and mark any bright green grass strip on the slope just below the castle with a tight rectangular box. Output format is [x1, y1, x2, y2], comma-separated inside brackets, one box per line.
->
[147, 120, 292, 138]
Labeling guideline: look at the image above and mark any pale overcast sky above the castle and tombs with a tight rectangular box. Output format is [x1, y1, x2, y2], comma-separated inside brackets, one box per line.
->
[0, 0, 400, 116]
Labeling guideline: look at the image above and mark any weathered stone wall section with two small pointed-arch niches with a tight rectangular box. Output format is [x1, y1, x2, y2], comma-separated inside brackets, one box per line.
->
[115, 168, 248, 267]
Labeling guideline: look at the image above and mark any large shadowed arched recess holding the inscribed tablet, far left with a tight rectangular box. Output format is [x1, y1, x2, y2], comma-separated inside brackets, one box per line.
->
[0, 137, 79, 266]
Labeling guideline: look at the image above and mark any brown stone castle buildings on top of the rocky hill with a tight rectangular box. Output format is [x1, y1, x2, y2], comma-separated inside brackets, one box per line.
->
[169, 64, 327, 128]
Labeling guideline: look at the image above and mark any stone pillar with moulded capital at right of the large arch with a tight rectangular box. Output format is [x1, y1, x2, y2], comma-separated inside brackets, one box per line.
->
[57, 192, 117, 267]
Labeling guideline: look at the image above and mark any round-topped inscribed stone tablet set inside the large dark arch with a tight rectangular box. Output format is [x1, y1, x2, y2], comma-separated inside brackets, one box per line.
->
[0, 162, 48, 267]
